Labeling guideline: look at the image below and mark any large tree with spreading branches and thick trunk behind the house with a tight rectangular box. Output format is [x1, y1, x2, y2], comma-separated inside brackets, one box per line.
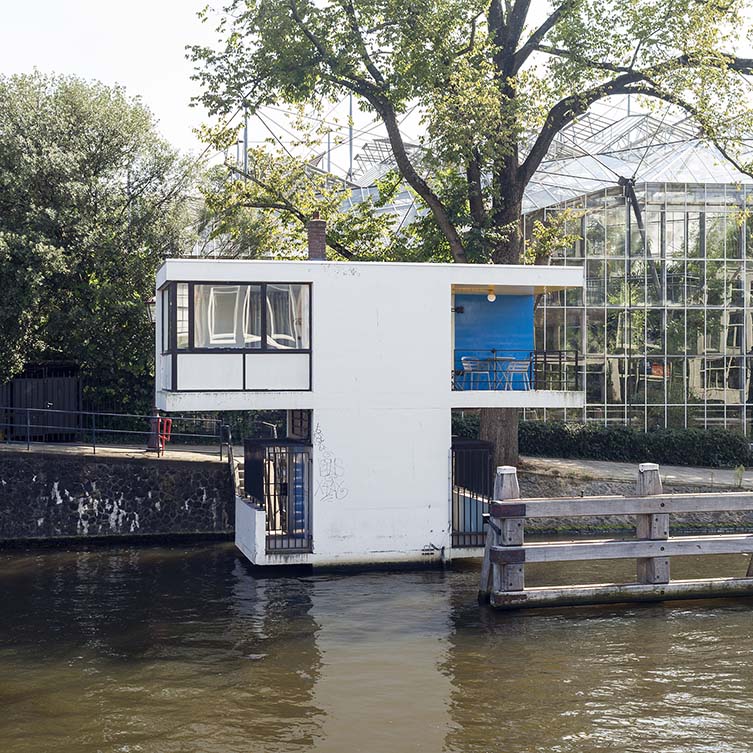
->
[192, 0, 753, 461]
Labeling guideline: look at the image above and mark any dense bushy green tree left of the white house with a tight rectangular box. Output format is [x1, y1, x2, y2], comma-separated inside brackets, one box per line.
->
[0, 72, 192, 411]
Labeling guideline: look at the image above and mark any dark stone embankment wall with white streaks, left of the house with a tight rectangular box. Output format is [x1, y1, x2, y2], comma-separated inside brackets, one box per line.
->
[0, 451, 235, 542]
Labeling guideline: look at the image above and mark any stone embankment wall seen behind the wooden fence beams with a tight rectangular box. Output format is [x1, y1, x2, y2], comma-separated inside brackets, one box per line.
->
[518, 471, 753, 534]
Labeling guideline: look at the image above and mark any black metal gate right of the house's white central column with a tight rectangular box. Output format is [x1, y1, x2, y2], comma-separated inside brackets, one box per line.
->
[452, 439, 494, 547]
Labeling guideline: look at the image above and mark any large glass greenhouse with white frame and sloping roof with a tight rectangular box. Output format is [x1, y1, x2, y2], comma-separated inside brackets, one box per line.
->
[524, 106, 753, 433]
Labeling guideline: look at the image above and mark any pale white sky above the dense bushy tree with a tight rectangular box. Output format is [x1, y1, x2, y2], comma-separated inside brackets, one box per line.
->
[0, 0, 213, 152]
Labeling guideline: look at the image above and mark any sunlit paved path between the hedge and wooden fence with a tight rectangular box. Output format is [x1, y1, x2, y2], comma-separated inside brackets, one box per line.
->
[520, 457, 753, 489]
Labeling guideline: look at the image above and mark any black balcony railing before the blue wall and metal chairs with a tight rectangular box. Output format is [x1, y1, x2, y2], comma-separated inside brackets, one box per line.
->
[452, 348, 581, 391]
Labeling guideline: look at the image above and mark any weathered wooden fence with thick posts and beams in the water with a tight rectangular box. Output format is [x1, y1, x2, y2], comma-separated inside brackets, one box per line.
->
[479, 463, 753, 609]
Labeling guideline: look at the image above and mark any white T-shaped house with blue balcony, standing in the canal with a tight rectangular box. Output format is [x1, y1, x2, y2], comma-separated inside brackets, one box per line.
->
[156, 259, 584, 566]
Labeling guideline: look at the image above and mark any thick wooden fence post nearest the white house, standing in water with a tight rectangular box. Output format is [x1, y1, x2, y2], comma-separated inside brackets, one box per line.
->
[479, 465, 525, 601]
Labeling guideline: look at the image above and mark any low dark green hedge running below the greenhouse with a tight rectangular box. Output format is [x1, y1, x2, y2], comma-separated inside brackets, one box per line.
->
[452, 414, 753, 468]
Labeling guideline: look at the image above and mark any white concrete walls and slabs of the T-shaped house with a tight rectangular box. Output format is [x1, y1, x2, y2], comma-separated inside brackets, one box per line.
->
[157, 260, 583, 564]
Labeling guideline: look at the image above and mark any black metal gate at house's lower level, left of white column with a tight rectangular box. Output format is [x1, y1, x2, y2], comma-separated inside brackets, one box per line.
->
[244, 439, 313, 552]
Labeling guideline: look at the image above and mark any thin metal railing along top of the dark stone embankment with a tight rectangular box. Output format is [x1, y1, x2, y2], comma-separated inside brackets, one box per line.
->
[0, 406, 229, 459]
